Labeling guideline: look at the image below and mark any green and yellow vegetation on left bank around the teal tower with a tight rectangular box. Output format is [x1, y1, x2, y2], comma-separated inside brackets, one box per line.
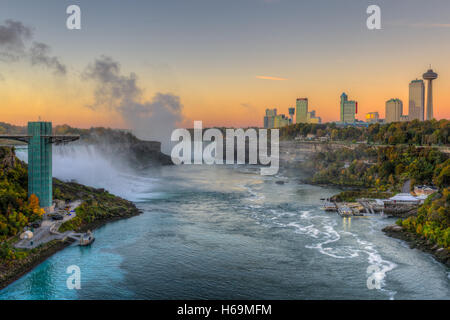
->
[0, 147, 139, 266]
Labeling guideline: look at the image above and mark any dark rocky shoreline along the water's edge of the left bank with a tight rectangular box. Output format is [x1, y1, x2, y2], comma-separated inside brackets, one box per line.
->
[0, 208, 142, 293]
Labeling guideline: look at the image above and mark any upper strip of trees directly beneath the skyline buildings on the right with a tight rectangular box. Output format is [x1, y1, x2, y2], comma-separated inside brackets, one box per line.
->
[280, 119, 450, 145]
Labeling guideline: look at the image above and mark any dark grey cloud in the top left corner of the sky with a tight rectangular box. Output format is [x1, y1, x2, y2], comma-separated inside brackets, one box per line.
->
[0, 20, 66, 75]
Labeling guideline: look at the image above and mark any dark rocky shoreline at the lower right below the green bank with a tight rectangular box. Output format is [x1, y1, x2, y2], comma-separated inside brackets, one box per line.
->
[381, 224, 450, 268]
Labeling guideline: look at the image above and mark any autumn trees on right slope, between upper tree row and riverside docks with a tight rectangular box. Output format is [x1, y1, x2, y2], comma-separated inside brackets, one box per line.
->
[310, 145, 450, 192]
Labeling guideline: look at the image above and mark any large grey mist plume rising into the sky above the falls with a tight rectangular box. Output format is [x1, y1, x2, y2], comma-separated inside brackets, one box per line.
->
[82, 56, 183, 153]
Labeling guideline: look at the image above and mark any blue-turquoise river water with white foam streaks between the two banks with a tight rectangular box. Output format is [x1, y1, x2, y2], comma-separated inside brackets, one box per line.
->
[0, 151, 450, 299]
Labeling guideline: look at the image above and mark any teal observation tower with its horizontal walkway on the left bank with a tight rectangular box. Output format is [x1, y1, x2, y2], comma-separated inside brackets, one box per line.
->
[0, 121, 80, 211]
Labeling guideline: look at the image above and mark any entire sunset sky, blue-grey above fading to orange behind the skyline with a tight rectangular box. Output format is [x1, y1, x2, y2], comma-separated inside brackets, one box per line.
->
[0, 0, 450, 135]
